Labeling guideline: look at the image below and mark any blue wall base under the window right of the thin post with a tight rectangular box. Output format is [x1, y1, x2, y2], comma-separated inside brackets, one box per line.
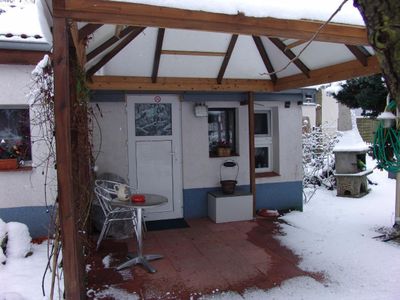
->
[256, 181, 303, 211]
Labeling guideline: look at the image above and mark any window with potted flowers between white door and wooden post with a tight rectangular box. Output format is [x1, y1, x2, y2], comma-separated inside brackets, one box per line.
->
[208, 108, 237, 157]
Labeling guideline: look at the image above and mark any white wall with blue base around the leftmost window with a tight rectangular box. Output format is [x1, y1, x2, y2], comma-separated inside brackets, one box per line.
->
[0, 65, 57, 236]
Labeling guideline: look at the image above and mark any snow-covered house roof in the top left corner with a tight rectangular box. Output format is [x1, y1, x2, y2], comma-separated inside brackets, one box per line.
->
[0, 1, 52, 50]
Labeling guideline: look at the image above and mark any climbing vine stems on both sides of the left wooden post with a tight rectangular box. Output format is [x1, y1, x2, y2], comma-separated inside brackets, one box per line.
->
[29, 55, 94, 299]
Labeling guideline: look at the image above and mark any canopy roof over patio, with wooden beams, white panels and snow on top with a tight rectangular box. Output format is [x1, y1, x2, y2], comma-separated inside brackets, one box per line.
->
[54, 0, 380, 91]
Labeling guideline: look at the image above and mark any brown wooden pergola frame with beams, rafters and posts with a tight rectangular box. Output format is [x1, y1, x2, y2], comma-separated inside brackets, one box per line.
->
[53, 0, 380, 299]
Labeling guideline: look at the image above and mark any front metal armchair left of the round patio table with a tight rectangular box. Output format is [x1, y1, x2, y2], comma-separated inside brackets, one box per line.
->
[94, 186, 137, 250]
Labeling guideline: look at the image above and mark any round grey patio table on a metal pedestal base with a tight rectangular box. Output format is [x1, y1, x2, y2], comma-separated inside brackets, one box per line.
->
[113, 194, 168, 273]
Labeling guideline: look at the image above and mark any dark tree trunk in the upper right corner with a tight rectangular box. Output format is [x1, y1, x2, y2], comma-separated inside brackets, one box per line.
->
[354, 0, 400, 107]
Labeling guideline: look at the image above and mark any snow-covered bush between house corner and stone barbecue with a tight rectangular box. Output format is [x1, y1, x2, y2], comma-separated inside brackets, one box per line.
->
[302, 126, 338, 202]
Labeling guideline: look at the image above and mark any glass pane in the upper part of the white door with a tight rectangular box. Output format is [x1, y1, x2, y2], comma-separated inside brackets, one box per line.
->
[135, 103, 172, 136]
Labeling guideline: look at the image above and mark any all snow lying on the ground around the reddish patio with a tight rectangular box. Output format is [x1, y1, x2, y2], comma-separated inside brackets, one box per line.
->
[0, 160, 400, 300]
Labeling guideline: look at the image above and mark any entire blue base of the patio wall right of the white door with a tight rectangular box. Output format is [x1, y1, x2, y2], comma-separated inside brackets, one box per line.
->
[183, 181, 303, 219]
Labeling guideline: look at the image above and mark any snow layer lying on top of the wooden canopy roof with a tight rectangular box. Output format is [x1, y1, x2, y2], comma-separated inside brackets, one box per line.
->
[111, 0, 364, 26]
